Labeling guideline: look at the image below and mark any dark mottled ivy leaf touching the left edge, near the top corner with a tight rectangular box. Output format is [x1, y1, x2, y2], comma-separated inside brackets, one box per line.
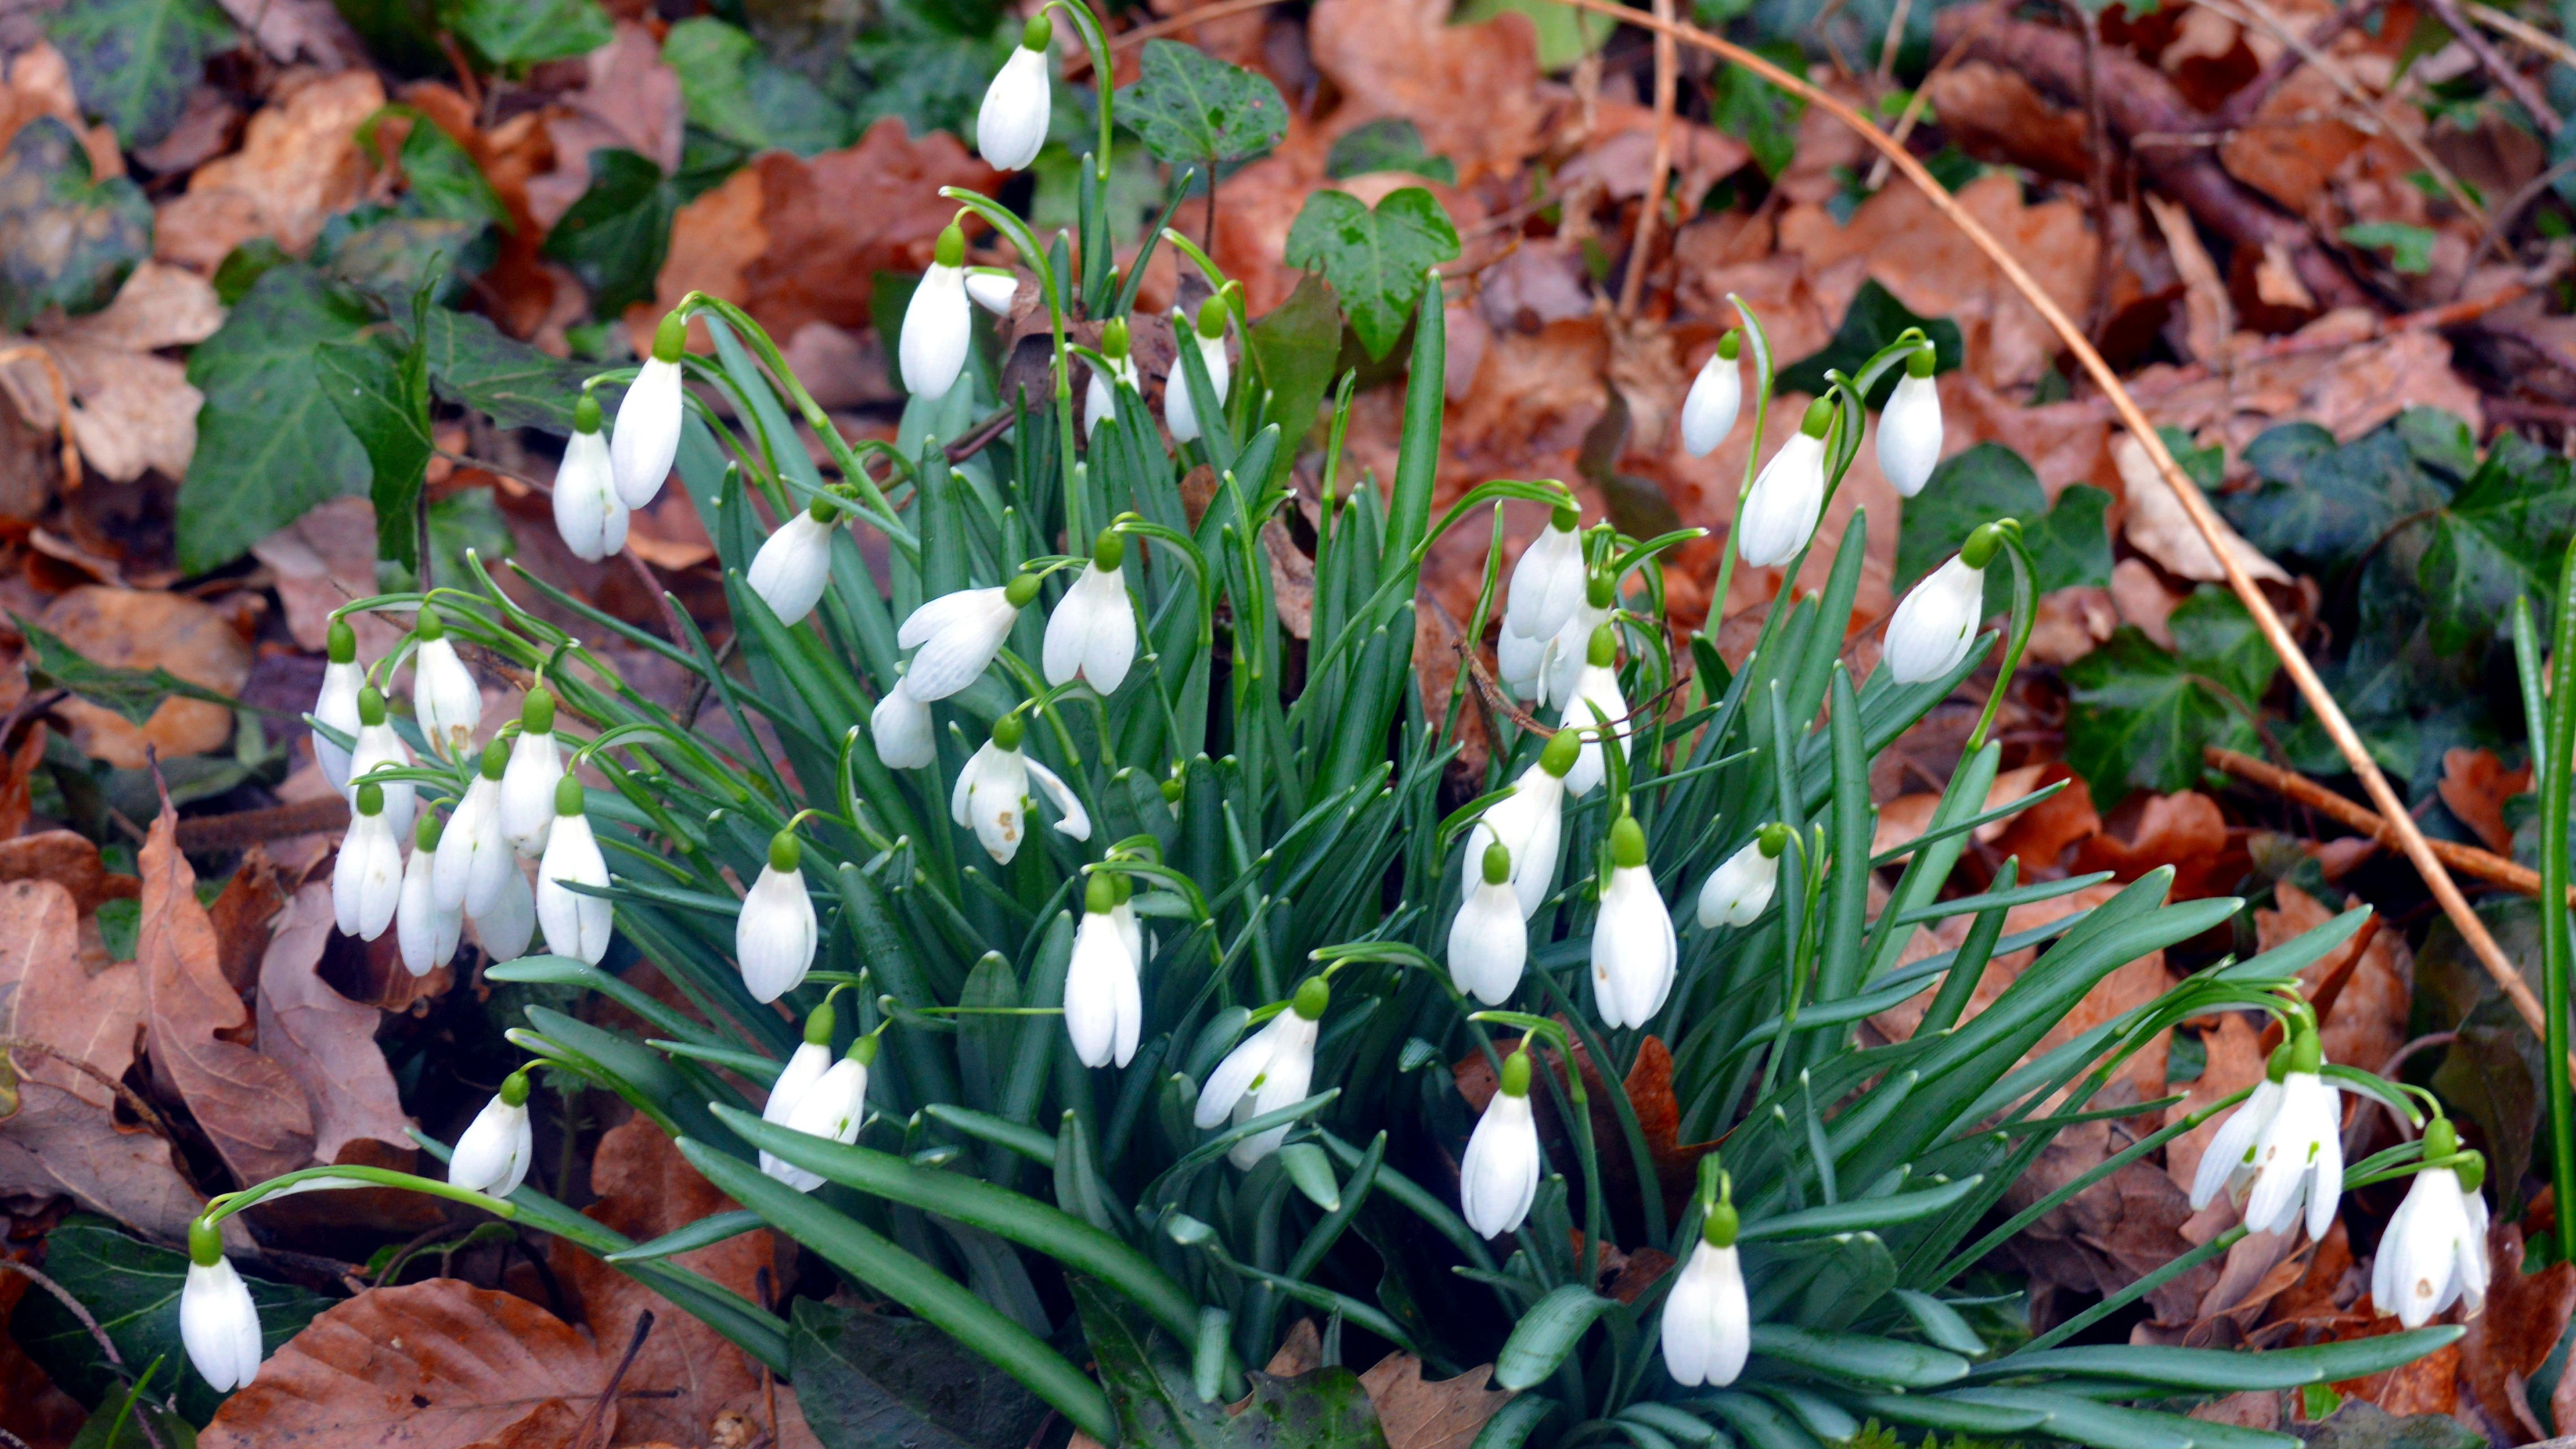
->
[0, 116, 152, 333]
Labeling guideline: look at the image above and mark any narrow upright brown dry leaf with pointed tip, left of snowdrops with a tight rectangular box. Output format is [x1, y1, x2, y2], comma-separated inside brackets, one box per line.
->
[137, 797, 314, 1183]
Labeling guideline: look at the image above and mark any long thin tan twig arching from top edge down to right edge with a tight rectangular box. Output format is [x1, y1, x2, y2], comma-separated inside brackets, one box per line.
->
[1564, 0, 2545, 1062]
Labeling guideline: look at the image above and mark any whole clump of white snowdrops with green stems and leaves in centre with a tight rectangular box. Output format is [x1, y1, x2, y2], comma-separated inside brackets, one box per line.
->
[183, 25, 2488, 1449]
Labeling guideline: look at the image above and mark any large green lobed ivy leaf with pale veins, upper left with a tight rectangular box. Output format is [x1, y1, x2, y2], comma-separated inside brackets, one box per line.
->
[178, 263, 374, 572]
